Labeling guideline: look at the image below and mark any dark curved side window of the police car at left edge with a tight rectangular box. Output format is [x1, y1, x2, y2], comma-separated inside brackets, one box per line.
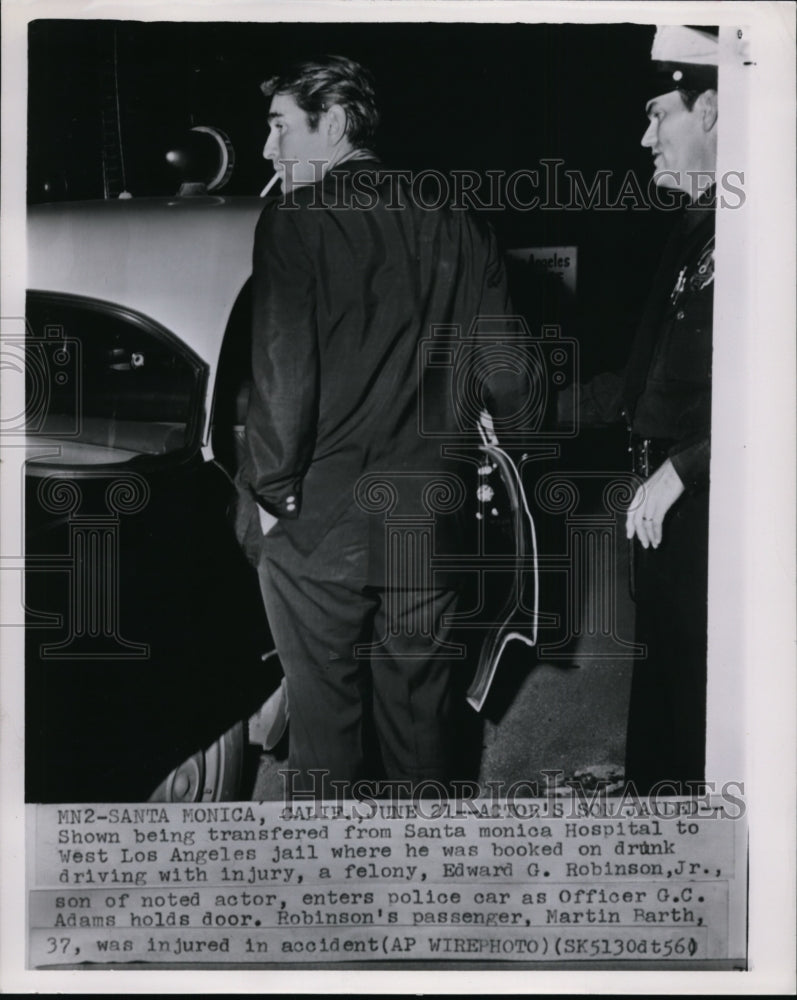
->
[26, 292, 207, 466]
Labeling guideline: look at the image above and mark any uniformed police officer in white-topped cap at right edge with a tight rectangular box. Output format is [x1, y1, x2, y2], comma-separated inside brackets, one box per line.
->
[564, 26, 718, 793]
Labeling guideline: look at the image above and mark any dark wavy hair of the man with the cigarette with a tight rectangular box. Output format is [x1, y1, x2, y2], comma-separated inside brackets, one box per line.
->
[260, 56, 379, 148]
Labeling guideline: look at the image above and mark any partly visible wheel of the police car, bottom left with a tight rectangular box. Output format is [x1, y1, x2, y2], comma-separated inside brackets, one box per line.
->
[149, 722, 246, 802]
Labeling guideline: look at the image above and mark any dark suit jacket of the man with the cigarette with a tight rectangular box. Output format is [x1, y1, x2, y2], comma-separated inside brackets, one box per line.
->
[239, 160, 529, 577]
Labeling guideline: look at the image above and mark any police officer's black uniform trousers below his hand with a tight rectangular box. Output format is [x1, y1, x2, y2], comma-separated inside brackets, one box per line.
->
[625, 491, 708, 794]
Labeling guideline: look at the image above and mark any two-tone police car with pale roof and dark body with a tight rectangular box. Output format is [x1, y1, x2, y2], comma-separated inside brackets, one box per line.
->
[25, 137, 279, 802]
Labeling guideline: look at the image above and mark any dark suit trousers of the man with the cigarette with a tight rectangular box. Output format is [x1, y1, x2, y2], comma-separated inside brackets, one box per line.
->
[258, 515, 462, 798]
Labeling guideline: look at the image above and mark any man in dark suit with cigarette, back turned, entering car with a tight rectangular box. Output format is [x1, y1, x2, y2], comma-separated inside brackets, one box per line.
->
[240, 56, 529, 795]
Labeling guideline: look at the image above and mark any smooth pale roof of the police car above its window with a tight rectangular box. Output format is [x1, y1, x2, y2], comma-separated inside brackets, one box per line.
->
[27, 196, 264, 369]
